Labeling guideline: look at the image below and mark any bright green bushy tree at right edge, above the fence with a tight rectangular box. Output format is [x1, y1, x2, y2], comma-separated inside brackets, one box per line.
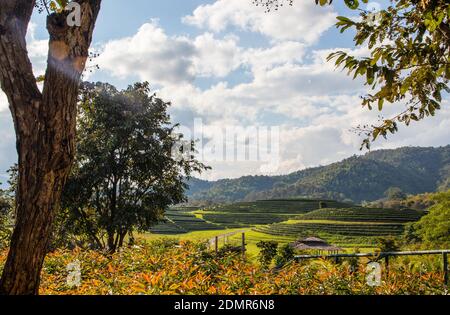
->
[413, 190, 450, 246]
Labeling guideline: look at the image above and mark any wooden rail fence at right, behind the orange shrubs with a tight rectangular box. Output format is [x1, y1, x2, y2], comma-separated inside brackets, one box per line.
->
[295, 249, 450, 285]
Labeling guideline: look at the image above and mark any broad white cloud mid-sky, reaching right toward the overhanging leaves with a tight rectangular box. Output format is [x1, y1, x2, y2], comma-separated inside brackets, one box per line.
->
[159, 43, 365, 123]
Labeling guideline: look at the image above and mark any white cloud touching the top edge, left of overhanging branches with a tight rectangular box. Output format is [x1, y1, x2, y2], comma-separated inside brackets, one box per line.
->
[183, 0, 336, 43]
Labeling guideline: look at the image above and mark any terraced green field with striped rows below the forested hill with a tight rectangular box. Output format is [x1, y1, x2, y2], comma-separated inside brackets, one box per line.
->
[145, 199, 425, 254]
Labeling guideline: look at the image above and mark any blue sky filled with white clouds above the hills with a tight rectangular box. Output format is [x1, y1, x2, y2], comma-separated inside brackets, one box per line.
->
[0, 0, 450, 182]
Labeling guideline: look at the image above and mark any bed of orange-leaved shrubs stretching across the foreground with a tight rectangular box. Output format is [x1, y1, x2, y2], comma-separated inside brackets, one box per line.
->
[0, 241, 446, 295]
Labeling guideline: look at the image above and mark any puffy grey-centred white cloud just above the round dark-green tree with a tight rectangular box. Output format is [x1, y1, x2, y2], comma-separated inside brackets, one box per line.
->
[96, 20, 250, 84]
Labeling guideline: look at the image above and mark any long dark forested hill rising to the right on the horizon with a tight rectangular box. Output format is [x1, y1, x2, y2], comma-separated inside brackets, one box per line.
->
[188, 145, 450, 202]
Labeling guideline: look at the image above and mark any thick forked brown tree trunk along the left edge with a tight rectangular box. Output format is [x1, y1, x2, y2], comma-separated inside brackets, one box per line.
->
[0, 0, 101, 295]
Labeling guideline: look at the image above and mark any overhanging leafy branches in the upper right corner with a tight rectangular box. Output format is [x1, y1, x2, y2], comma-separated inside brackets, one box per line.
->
[254, 0, 450, 148]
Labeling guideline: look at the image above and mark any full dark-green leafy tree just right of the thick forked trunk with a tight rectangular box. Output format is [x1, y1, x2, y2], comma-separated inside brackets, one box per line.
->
[63, 83, 206, 252]
